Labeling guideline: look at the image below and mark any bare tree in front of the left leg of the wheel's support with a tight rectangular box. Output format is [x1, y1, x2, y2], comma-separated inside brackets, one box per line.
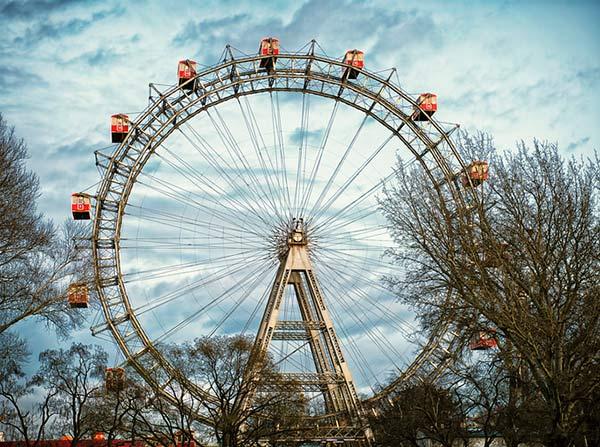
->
[166, 336, 305, 447]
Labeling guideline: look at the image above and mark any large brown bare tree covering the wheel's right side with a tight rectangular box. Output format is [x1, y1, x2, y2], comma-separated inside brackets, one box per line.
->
[381, 134, 600, 446]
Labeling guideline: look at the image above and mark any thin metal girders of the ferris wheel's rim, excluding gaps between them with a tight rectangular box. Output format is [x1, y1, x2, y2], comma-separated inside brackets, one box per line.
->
[93, 43, 476, 416]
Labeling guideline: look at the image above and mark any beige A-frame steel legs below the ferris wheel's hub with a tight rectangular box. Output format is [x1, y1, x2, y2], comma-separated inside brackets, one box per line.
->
[249, 240, 371, 445]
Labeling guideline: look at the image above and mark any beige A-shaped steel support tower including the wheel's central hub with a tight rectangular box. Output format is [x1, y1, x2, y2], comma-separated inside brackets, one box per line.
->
[247, 219, 372, 446]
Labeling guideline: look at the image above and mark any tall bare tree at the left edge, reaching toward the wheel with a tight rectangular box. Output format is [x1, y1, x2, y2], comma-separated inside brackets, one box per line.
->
[0, 114, 89, 335]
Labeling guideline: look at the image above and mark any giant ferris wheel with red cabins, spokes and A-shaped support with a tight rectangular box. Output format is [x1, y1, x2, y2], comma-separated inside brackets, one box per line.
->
[73, 38, 487, 444]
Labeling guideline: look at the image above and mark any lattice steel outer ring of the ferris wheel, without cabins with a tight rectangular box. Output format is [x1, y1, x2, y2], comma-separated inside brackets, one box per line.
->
[92, 49, 479, 425]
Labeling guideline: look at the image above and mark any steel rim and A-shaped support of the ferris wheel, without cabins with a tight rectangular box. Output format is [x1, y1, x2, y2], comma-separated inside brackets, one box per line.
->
[92, 41, 478, 443]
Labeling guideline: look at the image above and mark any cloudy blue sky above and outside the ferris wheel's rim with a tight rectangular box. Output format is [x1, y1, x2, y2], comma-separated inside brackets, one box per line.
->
[0, 0, 600, 396]
